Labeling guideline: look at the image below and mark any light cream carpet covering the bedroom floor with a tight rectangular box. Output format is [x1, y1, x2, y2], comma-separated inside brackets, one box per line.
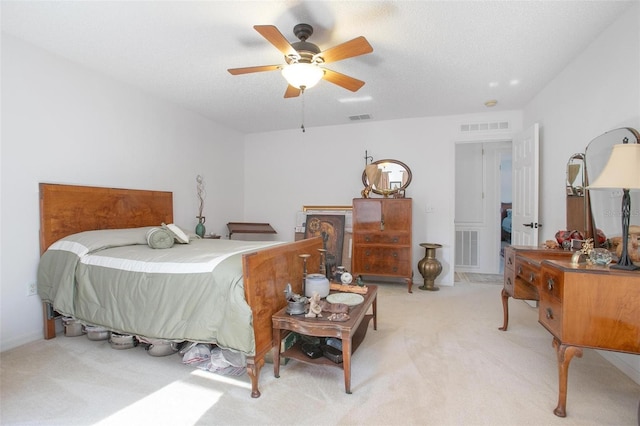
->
[0, 283, 640, 426]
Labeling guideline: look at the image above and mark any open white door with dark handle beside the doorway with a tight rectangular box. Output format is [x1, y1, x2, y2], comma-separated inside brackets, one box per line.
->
[511, 123, 542, 246]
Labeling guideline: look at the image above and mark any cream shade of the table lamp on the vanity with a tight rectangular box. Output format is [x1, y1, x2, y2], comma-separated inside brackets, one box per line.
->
[588, 143, 640, 189]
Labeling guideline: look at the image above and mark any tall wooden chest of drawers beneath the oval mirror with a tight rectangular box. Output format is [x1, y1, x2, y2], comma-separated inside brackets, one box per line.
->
[351, 198, 413, 292]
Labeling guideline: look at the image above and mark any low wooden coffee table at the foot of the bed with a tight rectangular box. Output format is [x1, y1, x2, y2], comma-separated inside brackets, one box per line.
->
[272, 285, 378, 393]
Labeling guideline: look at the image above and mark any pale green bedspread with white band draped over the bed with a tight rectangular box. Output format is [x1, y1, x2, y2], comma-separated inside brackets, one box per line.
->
[38, 228, 276, 355]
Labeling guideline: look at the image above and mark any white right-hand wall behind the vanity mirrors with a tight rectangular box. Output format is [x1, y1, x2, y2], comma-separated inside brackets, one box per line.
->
[524, 4, 640, 383]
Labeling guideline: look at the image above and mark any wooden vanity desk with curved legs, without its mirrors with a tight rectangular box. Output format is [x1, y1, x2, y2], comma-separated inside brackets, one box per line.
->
[500, 246, 640, 417]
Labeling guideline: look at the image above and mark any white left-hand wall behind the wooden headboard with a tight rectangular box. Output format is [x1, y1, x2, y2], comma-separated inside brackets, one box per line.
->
[0, 34, 244, 350]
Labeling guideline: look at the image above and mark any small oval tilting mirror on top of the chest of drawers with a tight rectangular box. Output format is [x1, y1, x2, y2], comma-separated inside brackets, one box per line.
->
[362, 159, 412, 197]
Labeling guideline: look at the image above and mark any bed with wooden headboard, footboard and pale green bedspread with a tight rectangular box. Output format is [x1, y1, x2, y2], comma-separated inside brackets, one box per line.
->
[38, 183, 322, 398]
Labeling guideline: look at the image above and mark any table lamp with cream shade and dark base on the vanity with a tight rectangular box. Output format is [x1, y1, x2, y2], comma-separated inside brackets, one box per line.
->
[588, 143, 640, 271]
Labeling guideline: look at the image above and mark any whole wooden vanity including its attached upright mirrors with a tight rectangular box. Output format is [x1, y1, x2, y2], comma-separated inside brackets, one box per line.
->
[500, 127, 640, 417]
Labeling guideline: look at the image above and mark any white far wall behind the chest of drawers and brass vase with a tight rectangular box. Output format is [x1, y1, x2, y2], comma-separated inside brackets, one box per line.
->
[245, 111, 521, 291]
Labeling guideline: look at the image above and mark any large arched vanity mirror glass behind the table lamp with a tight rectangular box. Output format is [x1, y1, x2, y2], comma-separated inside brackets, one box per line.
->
[585, 127, 640, 247]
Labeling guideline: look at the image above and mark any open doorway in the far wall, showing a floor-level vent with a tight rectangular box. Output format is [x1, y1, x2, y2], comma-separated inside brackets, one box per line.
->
[455, 141, 511, 274]
